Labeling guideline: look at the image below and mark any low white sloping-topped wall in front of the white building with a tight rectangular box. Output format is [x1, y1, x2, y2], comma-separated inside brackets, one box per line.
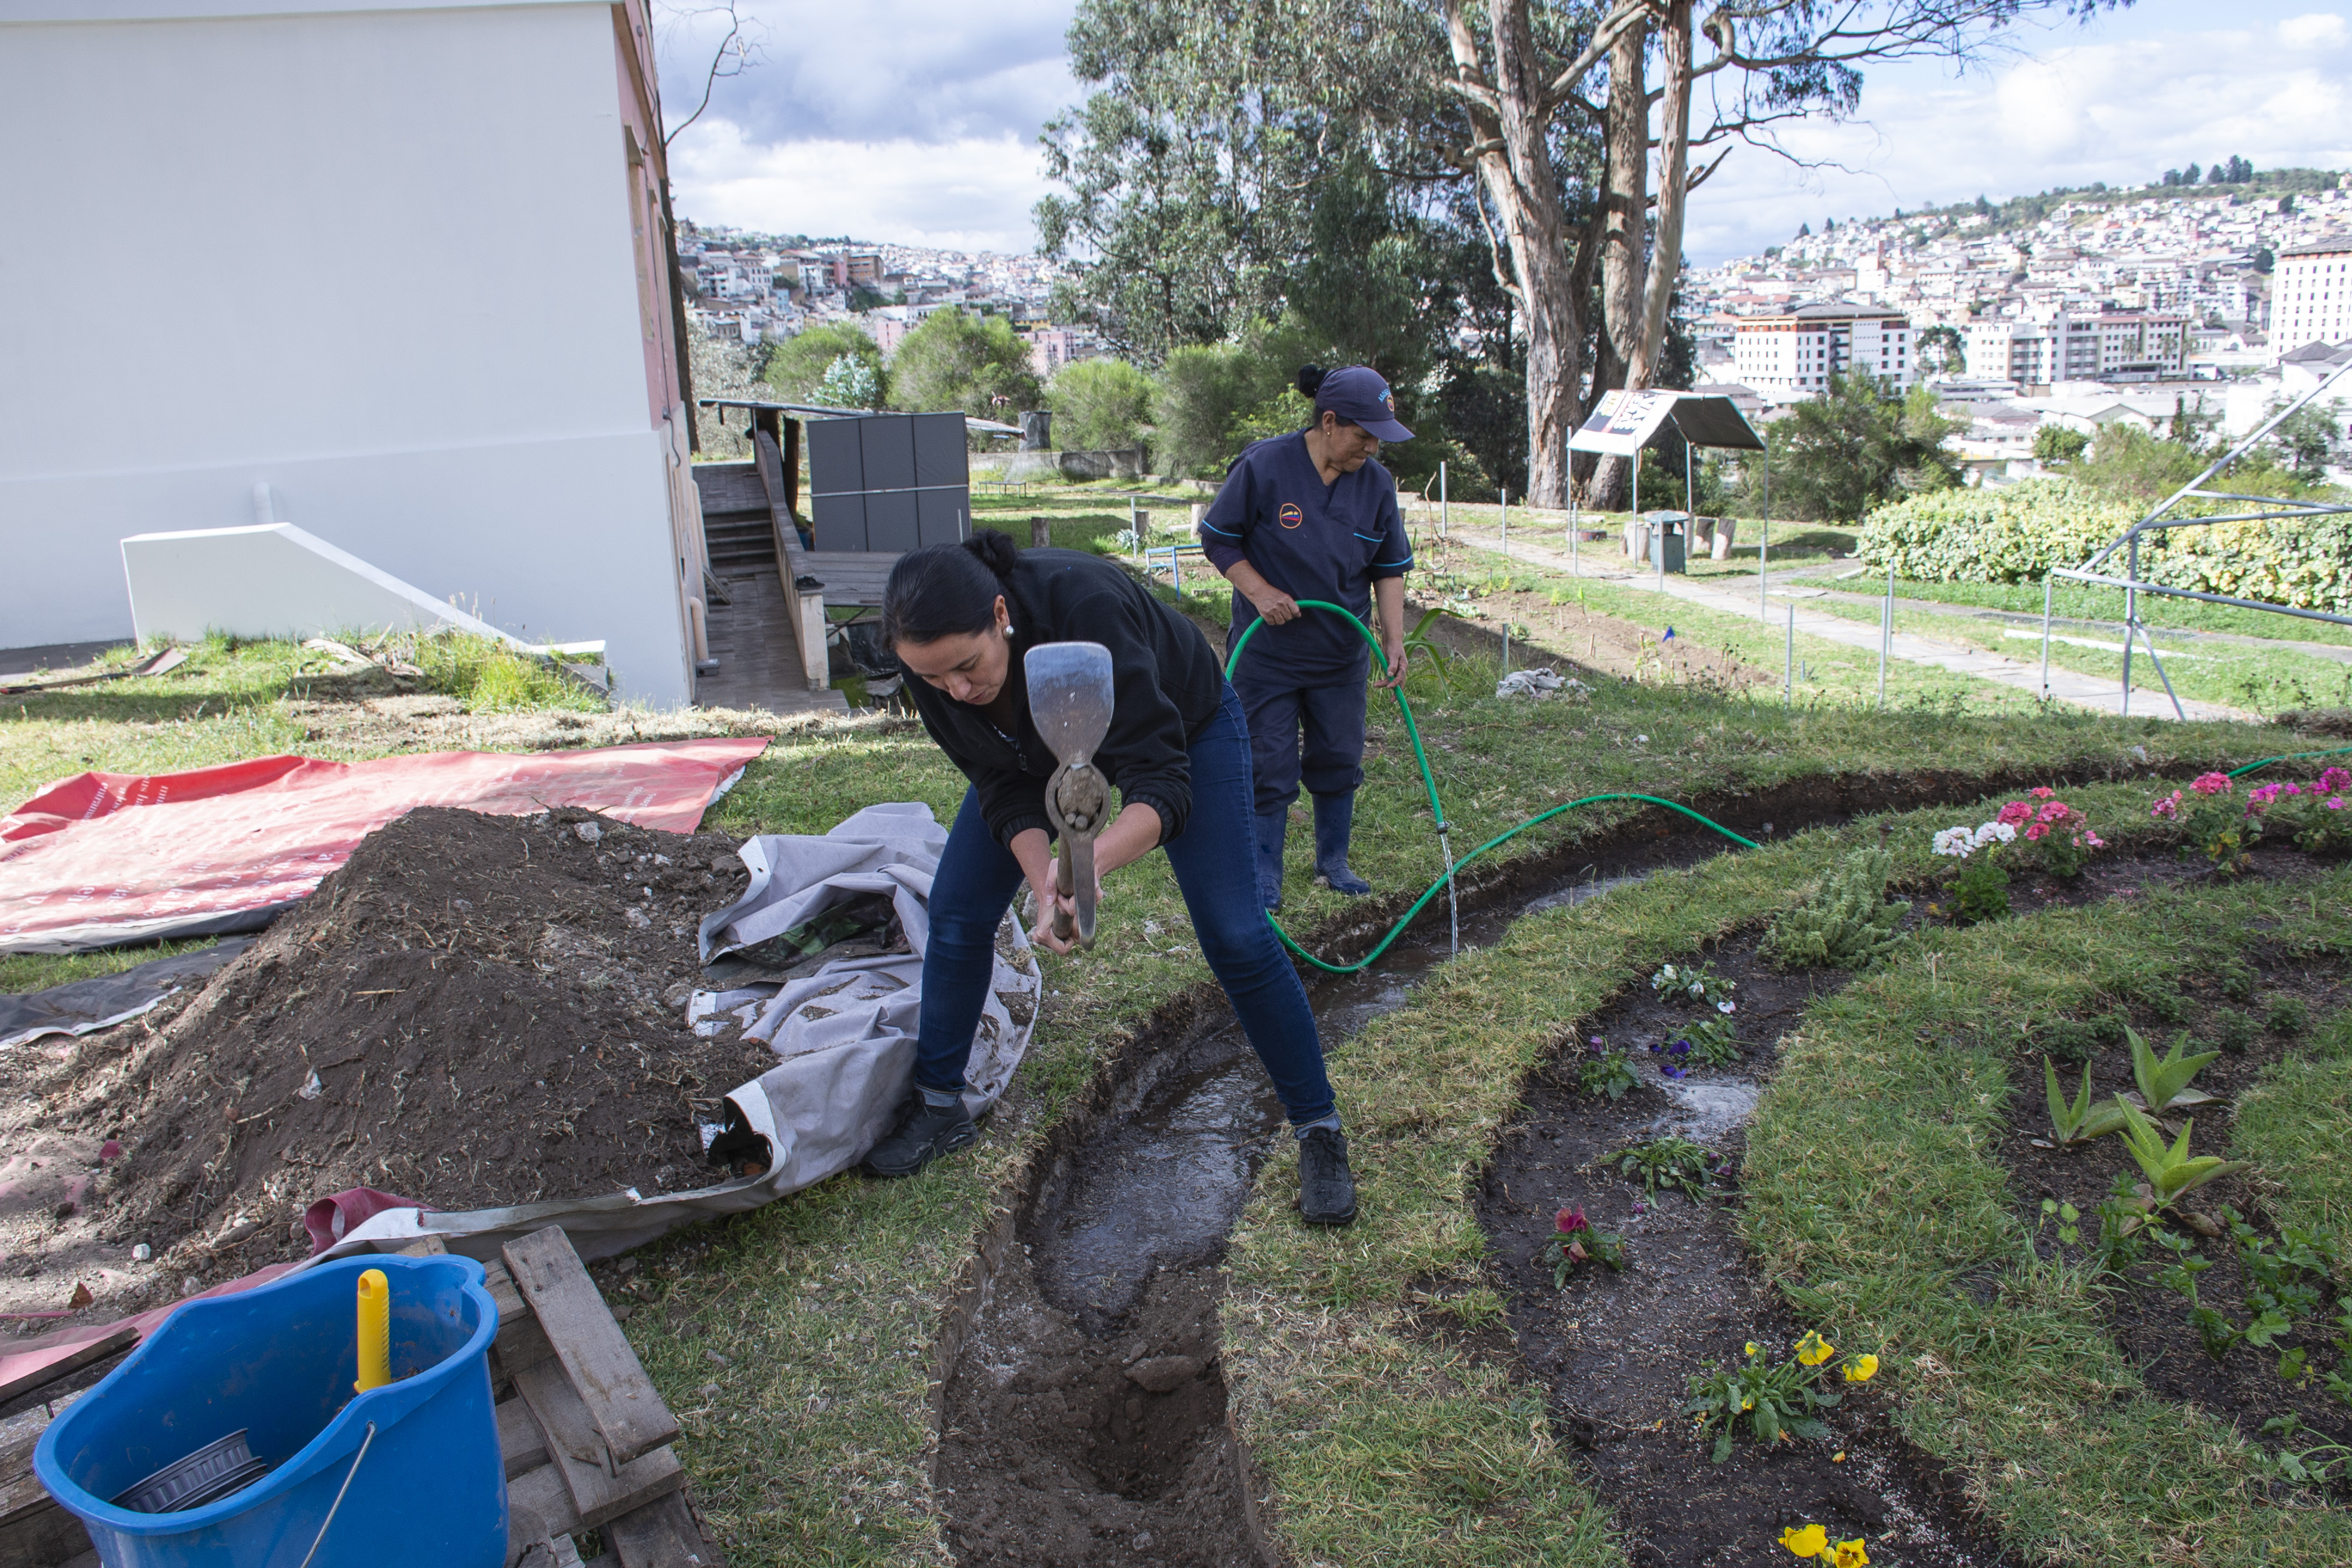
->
[122, 522, 525, 649]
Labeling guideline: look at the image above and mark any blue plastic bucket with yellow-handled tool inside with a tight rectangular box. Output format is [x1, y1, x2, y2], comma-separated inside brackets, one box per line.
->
[33, 1255, 506, 1568]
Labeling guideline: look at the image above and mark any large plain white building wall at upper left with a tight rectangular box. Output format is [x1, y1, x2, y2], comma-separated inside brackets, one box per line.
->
[0, 0, 689, 703]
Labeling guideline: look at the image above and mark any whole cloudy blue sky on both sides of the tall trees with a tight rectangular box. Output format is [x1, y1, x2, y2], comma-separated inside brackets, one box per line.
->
[663, 0, 2352, 266]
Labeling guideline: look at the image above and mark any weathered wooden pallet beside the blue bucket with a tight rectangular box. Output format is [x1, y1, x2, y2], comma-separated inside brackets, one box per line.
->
[0, 1227, 727, 1568]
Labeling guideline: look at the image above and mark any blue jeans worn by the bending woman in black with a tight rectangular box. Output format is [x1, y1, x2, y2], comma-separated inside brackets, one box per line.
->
[915, 687, 1334, 1126]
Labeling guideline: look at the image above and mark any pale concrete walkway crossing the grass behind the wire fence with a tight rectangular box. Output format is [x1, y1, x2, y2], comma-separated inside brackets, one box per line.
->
[1449, 517, 2260, 724]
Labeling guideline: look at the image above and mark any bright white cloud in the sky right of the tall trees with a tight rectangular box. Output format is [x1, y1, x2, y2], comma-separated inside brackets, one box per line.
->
[1686, 2, 2352, 266]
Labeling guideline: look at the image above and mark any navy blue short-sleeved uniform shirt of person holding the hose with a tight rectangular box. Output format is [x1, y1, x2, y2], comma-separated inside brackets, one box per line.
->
[1199, 433, 1414, 687]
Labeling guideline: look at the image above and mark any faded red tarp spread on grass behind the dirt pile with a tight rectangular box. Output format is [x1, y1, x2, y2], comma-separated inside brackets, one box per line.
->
[0, 738, 767, 952]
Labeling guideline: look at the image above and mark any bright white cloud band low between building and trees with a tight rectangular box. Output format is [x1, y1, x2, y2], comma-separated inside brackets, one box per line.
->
[670, 118, 1047, 252]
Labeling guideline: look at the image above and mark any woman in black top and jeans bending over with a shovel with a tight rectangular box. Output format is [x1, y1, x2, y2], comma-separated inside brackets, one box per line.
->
[865, 529, 1355, 1225]
